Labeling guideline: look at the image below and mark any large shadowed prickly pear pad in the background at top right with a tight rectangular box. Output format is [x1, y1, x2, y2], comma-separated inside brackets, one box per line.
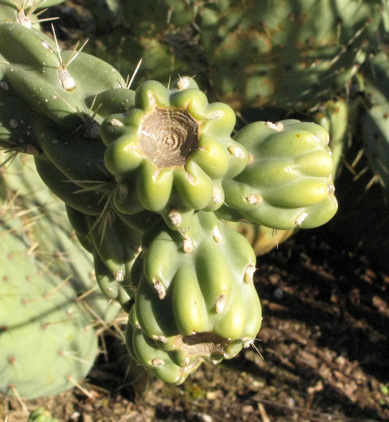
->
[197, 0, 389, 111]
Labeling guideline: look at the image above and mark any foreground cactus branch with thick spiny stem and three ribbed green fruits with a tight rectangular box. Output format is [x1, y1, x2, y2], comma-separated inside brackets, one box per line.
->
[0, 0, 340, 386]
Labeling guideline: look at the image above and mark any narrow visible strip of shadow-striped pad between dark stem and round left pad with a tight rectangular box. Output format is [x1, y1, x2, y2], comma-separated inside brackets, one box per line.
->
[0, 153, 120, 323]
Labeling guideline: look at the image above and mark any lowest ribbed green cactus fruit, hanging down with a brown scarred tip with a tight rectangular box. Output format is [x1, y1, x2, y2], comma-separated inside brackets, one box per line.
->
[127, 212, 262, 383]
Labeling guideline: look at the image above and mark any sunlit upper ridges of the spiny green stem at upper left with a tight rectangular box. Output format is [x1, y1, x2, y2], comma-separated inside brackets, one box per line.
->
[0, 19, 126, 131]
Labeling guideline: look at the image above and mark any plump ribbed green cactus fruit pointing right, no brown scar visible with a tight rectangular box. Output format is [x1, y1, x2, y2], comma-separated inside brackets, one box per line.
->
[218, 120, 337, 230]
